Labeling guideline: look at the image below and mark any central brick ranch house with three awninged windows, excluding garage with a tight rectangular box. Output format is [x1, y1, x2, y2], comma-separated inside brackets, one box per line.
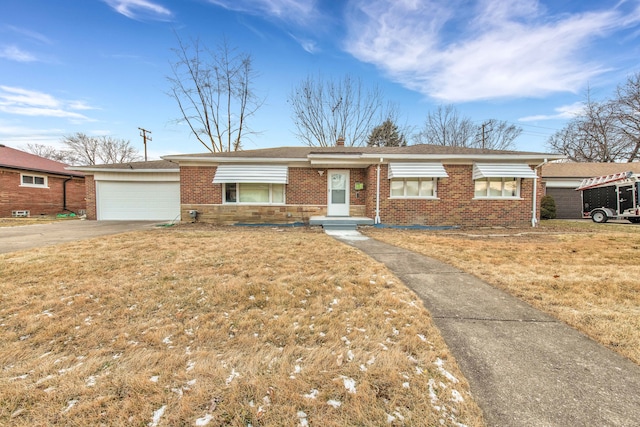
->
[163, 141, 564, 226]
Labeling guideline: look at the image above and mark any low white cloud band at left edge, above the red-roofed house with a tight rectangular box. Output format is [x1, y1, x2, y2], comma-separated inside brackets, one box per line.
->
[0, 86, 94, 121]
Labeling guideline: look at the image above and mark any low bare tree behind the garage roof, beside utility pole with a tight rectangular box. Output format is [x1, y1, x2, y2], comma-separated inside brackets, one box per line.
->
[62, 132, 142, 165]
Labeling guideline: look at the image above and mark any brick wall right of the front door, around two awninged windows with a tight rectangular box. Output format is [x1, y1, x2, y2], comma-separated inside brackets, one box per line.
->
[366, 165, 543, 226]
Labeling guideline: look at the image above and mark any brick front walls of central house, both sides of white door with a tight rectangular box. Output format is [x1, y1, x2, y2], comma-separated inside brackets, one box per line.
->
[180, 164, 544, 226]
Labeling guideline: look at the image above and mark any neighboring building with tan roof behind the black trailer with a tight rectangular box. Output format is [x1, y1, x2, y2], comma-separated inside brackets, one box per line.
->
[542, 162, 640, 219]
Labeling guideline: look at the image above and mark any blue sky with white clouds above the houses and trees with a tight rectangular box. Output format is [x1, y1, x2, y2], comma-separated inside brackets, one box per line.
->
[0, 0, 640, 159]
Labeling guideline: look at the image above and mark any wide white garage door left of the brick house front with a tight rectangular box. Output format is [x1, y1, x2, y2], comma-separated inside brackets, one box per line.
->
[96, 181, 180, 221]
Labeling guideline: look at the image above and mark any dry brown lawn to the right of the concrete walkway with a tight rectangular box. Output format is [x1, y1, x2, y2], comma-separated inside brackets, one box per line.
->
[366, 221, 640, 364]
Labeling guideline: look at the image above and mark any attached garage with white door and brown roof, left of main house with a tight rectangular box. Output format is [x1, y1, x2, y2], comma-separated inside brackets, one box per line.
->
[74, 160, 180, 221]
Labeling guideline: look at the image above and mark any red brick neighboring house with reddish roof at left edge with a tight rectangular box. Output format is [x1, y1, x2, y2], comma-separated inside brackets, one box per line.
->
[0, 144, 86, 217]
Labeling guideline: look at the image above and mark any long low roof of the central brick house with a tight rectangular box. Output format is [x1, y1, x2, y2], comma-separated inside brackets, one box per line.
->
[163, 144, 564, 161]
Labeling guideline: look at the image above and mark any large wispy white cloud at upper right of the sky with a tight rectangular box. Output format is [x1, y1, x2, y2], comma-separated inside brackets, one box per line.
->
[345, 0, 640, 102]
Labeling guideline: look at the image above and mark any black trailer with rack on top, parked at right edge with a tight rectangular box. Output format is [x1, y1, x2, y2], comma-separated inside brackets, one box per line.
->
[576, 172, 640, 224]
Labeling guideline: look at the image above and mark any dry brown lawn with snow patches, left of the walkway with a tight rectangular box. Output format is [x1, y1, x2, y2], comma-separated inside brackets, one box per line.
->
[0, 225, 482, 427]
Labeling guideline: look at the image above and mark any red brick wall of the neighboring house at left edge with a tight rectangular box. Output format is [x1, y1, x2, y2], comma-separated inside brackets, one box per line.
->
[0, 169, 86, 217]
